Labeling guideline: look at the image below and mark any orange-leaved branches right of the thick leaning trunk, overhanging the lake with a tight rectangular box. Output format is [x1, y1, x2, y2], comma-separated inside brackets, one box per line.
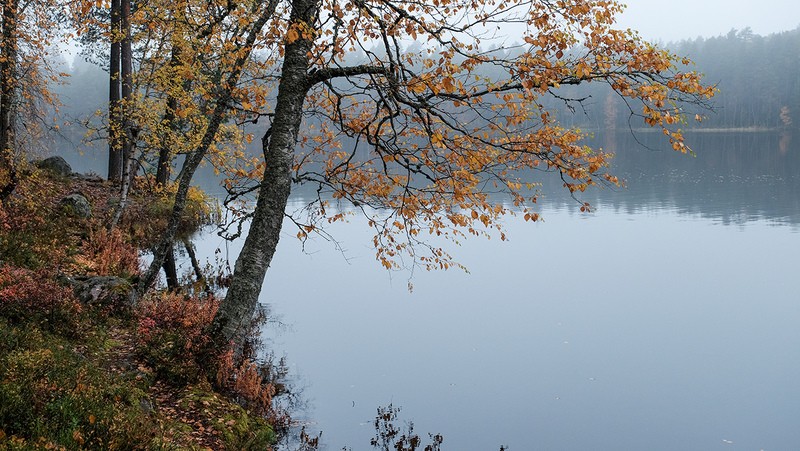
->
[278, 0, 714, 269]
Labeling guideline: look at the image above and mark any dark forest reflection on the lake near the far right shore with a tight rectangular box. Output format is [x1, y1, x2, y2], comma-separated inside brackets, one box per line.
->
[548, 132, 800, 225]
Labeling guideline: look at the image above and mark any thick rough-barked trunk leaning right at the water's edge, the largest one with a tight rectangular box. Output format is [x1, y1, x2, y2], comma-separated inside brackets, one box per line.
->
[213, 0, 319, 349]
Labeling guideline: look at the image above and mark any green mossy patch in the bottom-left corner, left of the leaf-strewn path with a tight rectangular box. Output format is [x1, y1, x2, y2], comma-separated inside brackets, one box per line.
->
[0, 319, 155, 449]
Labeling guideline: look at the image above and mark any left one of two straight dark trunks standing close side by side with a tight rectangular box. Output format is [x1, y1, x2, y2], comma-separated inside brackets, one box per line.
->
[108, 0, 122, 183]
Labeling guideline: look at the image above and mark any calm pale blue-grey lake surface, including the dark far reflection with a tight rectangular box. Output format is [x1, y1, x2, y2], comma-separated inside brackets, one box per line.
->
[189, 134, 800, 450]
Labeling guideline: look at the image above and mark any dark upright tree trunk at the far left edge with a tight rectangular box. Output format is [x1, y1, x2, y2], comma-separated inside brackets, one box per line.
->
[0, 0, 18, 202]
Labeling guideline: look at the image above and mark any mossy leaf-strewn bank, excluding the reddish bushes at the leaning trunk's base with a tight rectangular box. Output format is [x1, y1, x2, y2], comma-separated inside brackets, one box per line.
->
[0, 172, 276, 450]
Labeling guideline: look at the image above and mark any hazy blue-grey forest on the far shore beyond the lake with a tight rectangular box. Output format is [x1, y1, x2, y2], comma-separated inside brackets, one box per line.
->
[55, 27, 800, 154]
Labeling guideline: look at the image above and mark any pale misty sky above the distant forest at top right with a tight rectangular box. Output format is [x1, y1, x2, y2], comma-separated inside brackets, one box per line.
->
[619, 0, 800, 42]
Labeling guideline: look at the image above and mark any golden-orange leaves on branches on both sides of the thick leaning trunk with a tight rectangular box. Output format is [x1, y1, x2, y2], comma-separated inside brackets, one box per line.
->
[65, 0, 714, 276]
